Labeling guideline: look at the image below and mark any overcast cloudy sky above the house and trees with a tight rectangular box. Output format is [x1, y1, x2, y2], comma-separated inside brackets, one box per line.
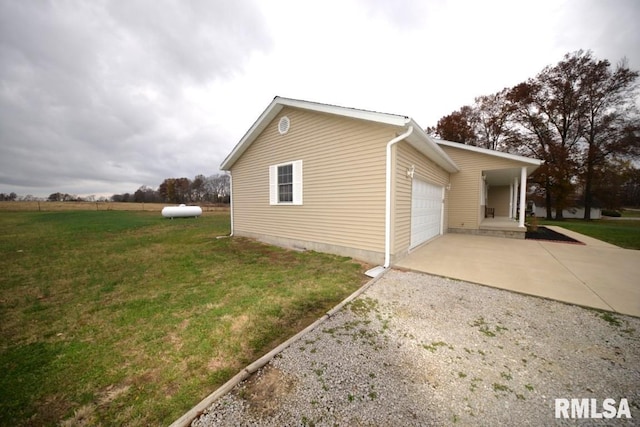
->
[0, 0, 640, 197]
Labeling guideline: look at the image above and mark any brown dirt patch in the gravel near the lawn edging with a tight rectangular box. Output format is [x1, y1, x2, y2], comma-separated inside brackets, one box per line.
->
[237, 365, 295, 416]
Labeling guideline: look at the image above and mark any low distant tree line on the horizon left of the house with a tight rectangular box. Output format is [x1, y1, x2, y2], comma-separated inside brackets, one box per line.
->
[0, 174, 230, 204]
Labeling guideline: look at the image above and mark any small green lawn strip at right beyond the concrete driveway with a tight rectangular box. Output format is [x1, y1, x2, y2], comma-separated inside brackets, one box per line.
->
[539, 219, 640, 249]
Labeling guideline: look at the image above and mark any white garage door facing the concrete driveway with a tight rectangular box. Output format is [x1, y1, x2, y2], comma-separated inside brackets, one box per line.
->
[411, 178, 443, 248]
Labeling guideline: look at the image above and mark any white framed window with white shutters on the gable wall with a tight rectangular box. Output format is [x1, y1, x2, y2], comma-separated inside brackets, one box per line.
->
[269, 160, 302, 205]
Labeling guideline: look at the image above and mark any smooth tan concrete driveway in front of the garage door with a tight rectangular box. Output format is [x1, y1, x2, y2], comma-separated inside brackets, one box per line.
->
[395, 226, 640, 317]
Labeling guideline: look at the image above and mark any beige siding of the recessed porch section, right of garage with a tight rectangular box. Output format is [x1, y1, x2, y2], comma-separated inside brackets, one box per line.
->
[441, 145, 522, 230]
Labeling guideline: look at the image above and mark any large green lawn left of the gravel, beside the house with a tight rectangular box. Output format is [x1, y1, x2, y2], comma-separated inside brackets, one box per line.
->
[0, 211, 366, 426]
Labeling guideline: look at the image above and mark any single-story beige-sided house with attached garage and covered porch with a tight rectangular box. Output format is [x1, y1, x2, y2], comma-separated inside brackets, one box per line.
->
[221, 97, 541, 267]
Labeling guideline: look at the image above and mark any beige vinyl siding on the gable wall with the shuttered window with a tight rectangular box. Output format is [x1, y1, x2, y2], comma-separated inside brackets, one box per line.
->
[231, 108, 395, 253]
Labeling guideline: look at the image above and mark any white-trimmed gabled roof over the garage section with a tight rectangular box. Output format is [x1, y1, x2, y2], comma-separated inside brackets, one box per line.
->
[220, 96, 459, 172]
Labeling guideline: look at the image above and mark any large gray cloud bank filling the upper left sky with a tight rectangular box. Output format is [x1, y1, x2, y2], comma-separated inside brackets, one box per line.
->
[0, 0, 270, 195]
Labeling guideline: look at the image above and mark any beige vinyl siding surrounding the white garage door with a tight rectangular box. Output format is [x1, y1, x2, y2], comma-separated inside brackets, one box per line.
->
[391, 141, 449, 259]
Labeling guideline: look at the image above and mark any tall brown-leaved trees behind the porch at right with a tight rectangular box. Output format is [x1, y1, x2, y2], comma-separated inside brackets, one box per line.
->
[427, 50, 640, 219]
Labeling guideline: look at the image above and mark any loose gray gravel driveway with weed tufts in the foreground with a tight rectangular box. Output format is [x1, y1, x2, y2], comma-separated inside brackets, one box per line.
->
[192, 270, 640, 426]
